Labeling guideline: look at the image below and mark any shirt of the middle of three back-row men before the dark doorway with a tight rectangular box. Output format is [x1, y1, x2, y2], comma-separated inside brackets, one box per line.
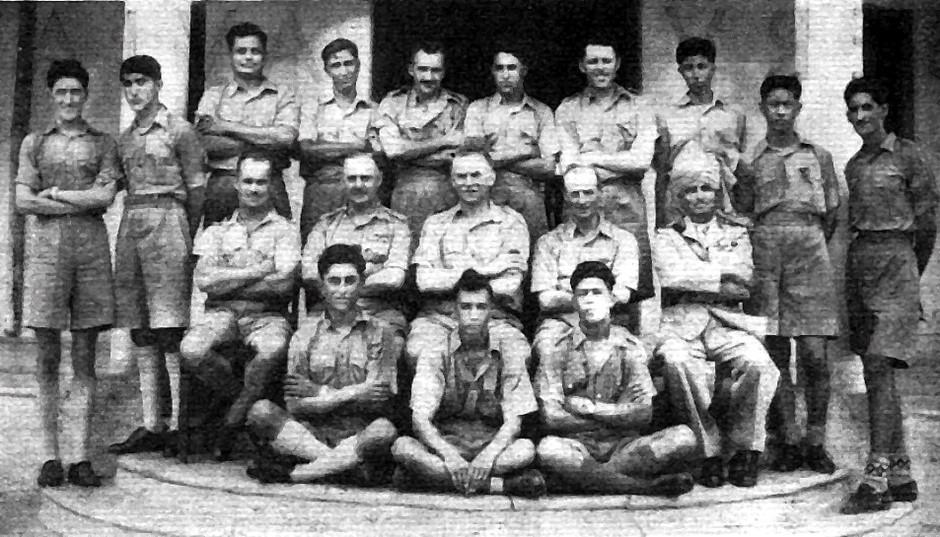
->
[464, 93, 561, 158]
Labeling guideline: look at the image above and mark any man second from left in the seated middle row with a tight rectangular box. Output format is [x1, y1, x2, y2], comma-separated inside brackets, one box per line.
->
[301, 154, 411, 360]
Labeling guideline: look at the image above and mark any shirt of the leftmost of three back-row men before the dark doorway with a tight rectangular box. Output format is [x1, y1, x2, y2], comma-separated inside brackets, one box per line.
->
[375, 88, 468, 163]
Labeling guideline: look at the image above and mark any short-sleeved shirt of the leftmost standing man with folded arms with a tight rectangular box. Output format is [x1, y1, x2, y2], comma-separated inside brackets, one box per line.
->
[16, 121, 122, 199]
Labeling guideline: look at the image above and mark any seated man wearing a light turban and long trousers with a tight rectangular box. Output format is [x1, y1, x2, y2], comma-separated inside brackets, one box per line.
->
[651, 147, 780, 487]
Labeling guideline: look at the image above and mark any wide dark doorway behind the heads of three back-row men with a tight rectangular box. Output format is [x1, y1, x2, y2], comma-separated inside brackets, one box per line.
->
[372, 0, 641, 108]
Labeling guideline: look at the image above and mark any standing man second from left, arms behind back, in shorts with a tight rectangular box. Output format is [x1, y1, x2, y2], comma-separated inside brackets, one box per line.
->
[109, 56, 206, 454]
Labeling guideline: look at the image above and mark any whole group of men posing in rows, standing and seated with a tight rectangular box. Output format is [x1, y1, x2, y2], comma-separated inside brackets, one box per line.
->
[16, 23, 937, 513]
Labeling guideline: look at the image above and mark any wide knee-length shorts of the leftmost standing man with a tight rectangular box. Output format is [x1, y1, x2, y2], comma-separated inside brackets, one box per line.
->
[23, 215, 114, 330]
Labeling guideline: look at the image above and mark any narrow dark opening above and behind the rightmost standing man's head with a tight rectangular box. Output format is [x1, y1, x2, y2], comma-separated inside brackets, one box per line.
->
[862, 4, 914, 138]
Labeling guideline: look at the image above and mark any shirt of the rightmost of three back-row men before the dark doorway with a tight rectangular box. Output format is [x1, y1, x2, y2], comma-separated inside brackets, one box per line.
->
[555, 85, 656, 181]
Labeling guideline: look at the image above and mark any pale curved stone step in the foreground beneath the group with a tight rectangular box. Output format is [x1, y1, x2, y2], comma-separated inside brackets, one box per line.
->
[40, 456, 912, 537]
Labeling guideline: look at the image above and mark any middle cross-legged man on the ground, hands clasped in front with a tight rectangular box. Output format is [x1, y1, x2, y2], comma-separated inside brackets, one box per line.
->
[392, 269, 545, 497]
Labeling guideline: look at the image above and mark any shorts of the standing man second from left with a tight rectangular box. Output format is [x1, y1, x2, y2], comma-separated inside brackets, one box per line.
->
[114, 198, 192, 328]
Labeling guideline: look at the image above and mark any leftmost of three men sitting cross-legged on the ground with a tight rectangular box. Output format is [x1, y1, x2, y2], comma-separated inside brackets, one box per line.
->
[248, 244, 401, 482]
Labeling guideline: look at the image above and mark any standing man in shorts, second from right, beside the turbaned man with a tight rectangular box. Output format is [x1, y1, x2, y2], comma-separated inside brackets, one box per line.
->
[747, 75, 840, 474]
